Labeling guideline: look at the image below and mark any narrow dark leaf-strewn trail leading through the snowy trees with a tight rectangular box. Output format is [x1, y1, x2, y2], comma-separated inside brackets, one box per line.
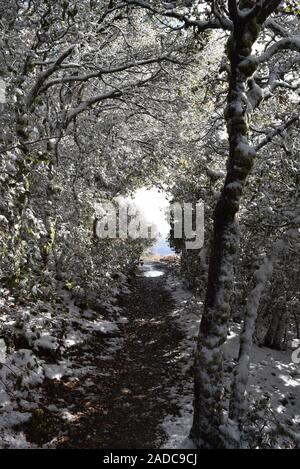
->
[27, 263, 183, 449]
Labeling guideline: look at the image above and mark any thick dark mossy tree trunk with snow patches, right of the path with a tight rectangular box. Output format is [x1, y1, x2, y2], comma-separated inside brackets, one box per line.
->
[191, 0, 279, 448]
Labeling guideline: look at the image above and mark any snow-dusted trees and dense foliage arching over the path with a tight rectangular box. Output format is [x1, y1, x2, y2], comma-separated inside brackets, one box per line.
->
[0, 0, 300, 447]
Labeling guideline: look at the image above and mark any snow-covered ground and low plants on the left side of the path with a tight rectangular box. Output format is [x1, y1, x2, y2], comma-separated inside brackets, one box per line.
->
[0, 290, 125, 448]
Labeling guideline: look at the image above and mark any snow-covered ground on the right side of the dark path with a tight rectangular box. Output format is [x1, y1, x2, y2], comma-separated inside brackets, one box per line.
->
[163, 268, 300, 448]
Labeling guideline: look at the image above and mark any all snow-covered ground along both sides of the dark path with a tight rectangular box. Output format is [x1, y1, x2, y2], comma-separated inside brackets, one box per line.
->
[0, 263, 300, 448]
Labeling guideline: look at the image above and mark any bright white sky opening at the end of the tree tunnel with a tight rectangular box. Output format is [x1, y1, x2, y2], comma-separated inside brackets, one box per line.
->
[133, 187, 170, 237]
